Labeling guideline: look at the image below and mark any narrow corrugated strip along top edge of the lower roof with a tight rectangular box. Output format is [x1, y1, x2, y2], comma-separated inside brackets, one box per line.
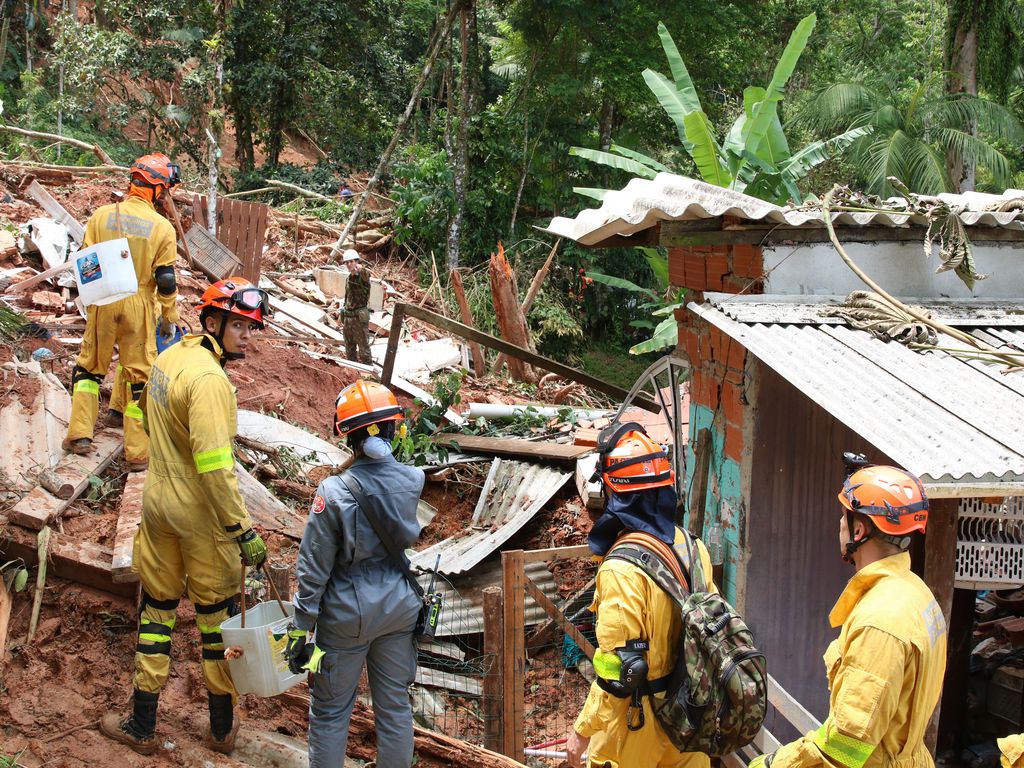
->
[705, 293, 1024, 328]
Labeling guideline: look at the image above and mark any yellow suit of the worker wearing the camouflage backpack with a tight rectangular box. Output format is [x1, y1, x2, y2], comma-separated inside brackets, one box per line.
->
[573, 529, 718, 768]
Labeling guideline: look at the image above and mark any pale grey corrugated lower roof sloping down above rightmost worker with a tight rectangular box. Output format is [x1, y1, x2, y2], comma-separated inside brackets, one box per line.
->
[688, 297, 1024, 490]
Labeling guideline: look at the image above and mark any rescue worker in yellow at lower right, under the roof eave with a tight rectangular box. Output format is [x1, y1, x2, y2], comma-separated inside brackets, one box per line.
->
[751, 454, 946, 768]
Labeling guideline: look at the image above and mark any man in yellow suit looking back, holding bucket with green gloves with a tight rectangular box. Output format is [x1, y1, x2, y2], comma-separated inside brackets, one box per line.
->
[99, 278, 267, 755]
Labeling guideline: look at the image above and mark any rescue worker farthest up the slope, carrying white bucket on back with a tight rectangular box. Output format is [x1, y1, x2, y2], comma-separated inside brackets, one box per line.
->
[65, 153, 179, 470]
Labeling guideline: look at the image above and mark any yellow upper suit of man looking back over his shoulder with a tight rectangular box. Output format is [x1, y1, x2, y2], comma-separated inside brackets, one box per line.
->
[140, 334, 252, 538]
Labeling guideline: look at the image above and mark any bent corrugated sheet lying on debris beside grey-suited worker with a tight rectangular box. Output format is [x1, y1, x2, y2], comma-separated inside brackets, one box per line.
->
[413, 459, 572, 574]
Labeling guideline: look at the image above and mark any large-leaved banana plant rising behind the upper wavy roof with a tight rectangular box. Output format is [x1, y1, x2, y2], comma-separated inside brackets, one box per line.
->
[569, 13, 871, 205]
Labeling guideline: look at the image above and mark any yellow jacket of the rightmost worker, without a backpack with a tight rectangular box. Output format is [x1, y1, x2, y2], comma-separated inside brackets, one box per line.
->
[771, 552, 946, 768]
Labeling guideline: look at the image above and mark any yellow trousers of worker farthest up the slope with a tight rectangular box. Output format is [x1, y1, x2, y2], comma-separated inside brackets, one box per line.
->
[68, 294, 157, 462]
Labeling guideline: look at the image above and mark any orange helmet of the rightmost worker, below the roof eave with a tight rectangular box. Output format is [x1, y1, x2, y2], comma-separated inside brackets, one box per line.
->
[839, 464, 928, 546]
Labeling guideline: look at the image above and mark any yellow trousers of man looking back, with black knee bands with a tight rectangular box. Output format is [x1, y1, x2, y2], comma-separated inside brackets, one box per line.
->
[133, 462, 242, 702]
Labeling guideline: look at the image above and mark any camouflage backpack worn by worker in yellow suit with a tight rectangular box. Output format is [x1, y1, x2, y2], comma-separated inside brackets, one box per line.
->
[605, 531, 768, 757]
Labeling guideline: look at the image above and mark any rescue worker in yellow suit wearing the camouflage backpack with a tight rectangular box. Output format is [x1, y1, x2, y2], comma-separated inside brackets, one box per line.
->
[566, 423, 718, 768]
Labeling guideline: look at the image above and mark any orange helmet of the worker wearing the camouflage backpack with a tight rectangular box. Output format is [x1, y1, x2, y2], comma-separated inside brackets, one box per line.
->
[598, 422, 676, 494]
